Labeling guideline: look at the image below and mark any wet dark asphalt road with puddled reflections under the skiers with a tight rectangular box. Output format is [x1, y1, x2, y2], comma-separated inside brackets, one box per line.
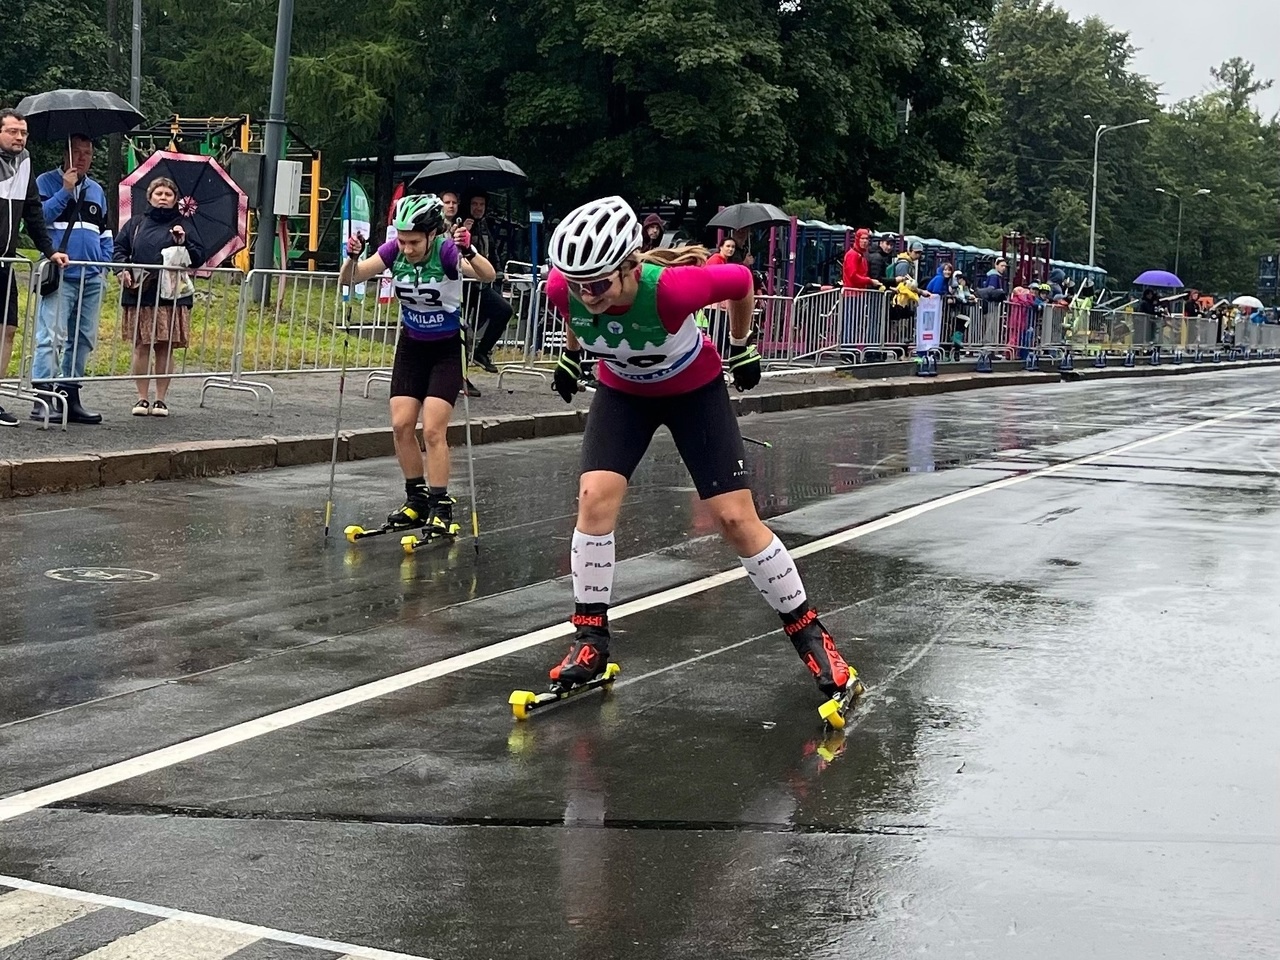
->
[0, 371, 1280, 960]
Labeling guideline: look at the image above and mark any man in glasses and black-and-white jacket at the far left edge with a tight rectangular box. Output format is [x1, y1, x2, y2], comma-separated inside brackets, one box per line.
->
[0, 108, 69, 426]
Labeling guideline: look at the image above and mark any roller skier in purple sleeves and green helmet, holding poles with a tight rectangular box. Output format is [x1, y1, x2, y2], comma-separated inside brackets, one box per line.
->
[338, 193, 497, 536]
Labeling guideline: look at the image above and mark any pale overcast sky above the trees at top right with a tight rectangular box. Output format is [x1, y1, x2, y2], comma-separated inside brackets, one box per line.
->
[1055, 0, 1280, 116]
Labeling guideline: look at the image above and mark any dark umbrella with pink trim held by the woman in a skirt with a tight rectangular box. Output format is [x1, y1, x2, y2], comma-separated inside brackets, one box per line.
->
[120, 150, 248, 266]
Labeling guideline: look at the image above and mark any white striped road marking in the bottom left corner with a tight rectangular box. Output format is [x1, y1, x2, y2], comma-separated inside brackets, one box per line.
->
[0, 876, 428, 960]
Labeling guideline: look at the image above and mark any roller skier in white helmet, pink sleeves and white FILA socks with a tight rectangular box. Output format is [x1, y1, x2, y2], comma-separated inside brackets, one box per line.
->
[524, 197, 861, 726]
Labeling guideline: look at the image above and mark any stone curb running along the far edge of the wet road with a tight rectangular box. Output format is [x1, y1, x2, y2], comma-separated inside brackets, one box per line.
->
[0, 360, 1280, 499]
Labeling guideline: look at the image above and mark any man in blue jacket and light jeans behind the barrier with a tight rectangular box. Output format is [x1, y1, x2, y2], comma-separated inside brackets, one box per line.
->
[31, 136, 114, 424]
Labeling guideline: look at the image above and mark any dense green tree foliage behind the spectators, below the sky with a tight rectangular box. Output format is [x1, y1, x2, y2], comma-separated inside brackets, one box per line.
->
[0, 0, 1280, 289]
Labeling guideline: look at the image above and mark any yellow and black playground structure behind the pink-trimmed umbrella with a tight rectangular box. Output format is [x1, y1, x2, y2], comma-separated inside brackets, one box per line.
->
[125, 114, 332, 270]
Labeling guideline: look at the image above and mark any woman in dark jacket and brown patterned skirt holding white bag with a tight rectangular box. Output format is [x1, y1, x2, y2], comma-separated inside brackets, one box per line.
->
[113, 177, 205, 417]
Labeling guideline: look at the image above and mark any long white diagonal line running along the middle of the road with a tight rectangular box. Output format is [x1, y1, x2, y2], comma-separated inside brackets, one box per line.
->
[0, 401, 1280, 823]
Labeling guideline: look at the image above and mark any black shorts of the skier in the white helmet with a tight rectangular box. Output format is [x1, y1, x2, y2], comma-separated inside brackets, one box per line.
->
[582, 378, 750, 500]
